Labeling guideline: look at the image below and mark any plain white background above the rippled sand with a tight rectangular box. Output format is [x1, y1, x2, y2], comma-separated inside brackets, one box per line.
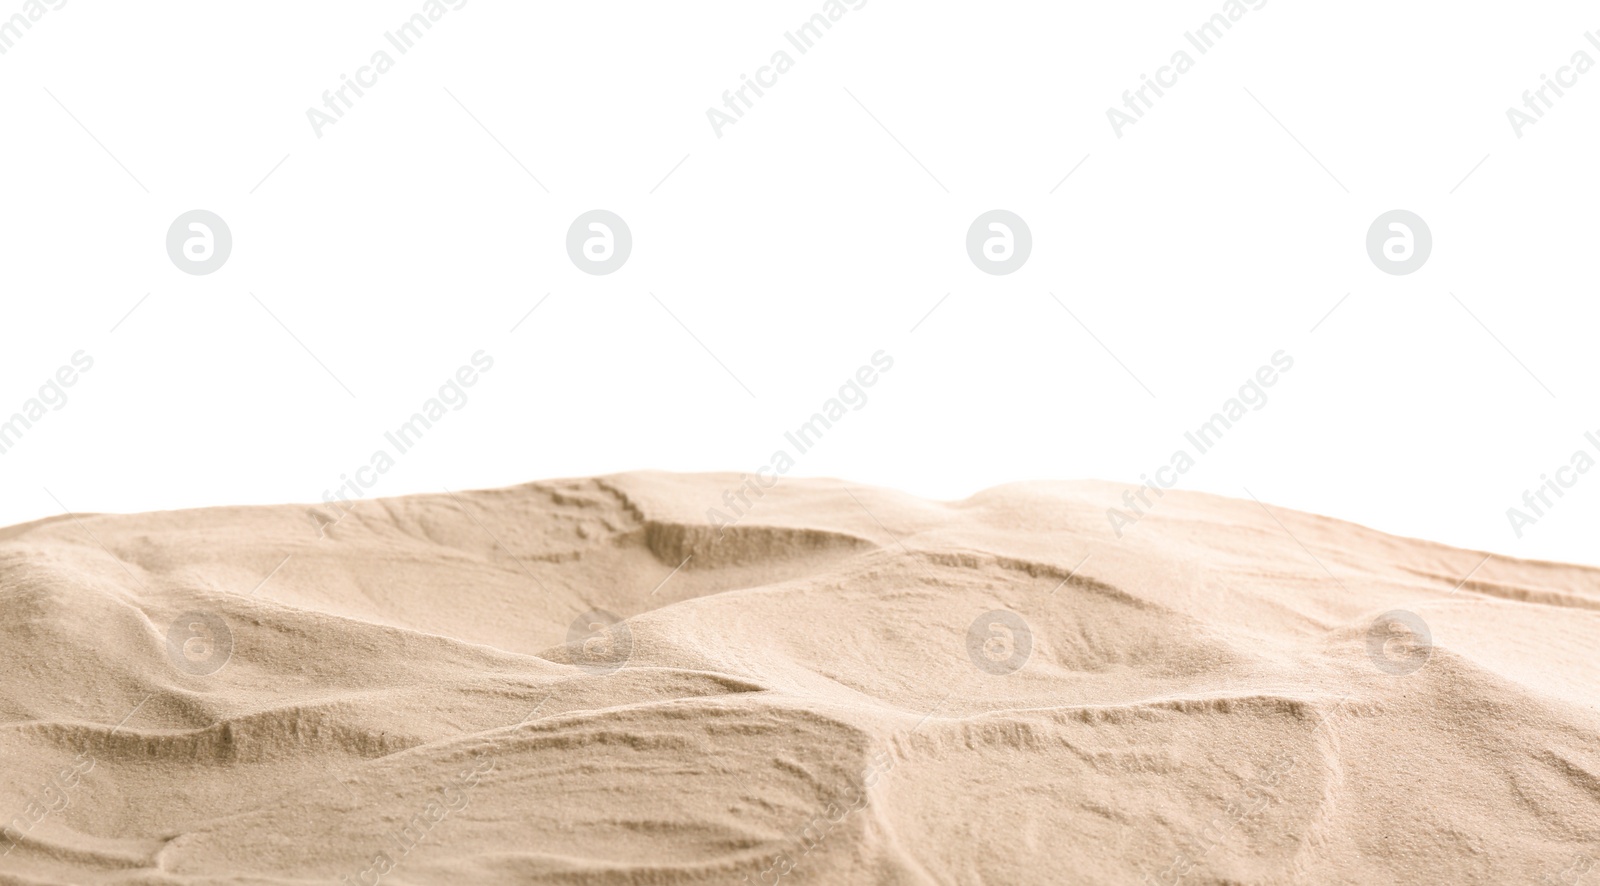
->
[0, 0, 1600, 563]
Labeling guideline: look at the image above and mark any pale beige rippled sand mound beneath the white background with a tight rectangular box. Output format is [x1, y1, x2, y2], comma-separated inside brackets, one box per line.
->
[0, 473, 1600, 884]
